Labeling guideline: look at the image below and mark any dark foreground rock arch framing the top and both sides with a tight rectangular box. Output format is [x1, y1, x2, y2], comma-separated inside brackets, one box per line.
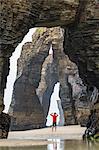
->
[0, 0, 99, 136]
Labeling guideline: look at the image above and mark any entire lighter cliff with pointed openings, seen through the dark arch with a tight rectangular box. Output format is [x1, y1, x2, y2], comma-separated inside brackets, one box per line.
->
[9, 27, 93, 130]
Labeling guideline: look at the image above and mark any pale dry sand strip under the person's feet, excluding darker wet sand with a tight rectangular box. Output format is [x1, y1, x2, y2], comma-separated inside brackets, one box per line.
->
[8, 125, 86, 140]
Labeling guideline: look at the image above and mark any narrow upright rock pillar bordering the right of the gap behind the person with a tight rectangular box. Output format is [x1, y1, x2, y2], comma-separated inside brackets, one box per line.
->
[52, 28, 76, 125]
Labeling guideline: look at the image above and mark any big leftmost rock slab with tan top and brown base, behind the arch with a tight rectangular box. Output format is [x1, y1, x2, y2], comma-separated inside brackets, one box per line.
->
[10, 29, 49, 130]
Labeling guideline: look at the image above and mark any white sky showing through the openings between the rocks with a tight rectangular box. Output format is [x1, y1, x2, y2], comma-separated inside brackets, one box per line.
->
[4, 28, 59, 125]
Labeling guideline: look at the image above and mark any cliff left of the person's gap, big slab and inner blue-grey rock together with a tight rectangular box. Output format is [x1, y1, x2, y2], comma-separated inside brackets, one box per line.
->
[9, 28, 57, 130]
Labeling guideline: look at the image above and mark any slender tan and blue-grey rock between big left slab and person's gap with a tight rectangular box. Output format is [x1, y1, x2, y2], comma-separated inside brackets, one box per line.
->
[37, 54, 58, 123]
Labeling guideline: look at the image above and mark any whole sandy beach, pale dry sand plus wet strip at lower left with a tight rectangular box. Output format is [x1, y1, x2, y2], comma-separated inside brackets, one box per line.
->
[0, 125, 86, 146]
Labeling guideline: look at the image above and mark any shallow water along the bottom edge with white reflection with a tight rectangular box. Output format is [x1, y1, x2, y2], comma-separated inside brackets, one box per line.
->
[0, 139, 99, 150]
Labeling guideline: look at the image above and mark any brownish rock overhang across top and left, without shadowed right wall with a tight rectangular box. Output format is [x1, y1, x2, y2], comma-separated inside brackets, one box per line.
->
[0, 0, 78, 114]
